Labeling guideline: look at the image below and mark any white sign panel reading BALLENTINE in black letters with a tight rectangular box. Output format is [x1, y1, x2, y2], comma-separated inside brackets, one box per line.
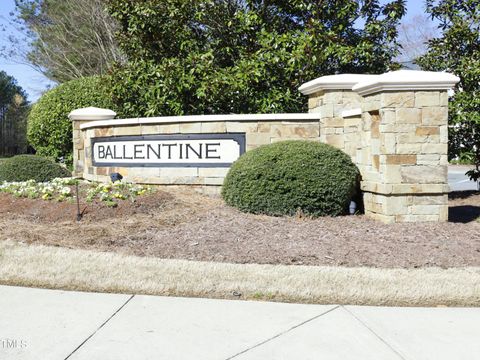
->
[92, 134, 245, 167]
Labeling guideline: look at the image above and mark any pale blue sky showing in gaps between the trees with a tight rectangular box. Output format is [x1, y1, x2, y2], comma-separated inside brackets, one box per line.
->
[0, 0, 434, 102]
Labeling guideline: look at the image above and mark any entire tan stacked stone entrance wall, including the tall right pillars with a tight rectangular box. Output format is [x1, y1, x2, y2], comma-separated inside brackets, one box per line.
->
[73, 75, 449, 223]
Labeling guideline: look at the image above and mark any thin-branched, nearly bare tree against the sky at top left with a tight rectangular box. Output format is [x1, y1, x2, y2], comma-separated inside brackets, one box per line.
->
[8, 0, 123, 83]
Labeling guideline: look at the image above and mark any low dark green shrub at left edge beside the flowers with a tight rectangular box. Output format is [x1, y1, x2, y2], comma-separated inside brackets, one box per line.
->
[0, 155, 71, 182]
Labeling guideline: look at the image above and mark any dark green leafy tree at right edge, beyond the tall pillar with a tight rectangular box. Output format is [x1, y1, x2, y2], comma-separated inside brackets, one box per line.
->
[417, 0, 480, 181]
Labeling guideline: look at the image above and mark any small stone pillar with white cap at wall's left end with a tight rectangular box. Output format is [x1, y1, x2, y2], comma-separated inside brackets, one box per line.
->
[68, 107, 117, 177]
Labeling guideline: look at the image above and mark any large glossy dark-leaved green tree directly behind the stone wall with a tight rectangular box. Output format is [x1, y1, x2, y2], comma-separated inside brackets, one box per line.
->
[107, 0, 405, 116]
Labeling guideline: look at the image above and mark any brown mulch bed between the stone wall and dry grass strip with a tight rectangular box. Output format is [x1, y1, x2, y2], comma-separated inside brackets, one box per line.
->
[0, 189, 480, 268]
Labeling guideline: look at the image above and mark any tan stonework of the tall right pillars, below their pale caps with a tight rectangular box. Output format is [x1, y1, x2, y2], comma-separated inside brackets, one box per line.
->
[309, 90, 448, 222]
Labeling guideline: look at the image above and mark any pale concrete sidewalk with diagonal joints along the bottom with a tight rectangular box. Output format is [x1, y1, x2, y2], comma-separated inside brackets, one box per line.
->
[0, 286, 480, 360]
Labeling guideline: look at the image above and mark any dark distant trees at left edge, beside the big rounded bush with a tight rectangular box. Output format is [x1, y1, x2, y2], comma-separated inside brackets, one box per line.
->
[0, 71, 29, 155]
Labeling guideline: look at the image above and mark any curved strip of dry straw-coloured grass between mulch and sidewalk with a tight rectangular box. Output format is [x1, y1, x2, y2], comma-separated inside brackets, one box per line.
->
[0, 241, 480, 306]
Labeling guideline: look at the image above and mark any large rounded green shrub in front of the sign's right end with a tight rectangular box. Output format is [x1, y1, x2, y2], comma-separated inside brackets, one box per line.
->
[222, 141, 359, 216]
